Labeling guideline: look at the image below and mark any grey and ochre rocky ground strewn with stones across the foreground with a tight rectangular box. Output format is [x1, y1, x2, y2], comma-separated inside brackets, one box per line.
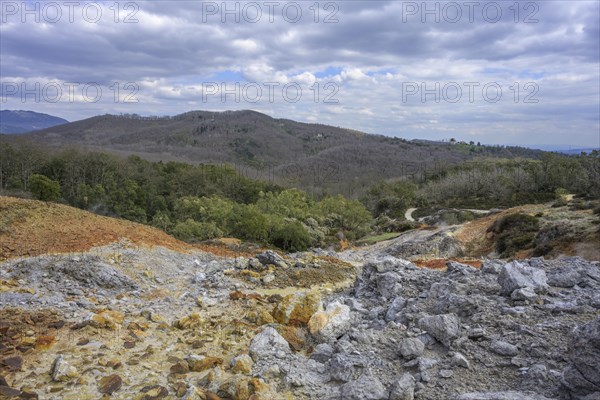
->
[0, 198, 600, 400]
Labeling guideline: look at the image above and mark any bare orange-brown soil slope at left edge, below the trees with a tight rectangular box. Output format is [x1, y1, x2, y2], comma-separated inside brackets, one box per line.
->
[0, 196, 193, 260]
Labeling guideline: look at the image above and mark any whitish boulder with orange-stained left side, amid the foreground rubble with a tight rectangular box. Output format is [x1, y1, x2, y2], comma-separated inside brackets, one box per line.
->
[308, 301, 351, 342]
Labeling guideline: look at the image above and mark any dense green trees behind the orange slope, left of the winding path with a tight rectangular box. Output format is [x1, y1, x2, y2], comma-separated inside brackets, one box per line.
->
[0, 143, 372, 251]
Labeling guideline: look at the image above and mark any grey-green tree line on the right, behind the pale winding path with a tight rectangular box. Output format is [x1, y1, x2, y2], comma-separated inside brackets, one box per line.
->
[362, 151, 600, 218]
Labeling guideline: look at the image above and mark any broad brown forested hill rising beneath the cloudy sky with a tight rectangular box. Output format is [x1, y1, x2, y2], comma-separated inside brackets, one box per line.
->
[11, 111, 542, 194]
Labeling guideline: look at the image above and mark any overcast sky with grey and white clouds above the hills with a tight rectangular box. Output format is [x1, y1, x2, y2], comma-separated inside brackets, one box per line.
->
[0, 0, 600, 147]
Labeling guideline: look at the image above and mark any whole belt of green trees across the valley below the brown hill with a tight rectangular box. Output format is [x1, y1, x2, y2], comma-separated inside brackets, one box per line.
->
[0, 134, 600, 250]
